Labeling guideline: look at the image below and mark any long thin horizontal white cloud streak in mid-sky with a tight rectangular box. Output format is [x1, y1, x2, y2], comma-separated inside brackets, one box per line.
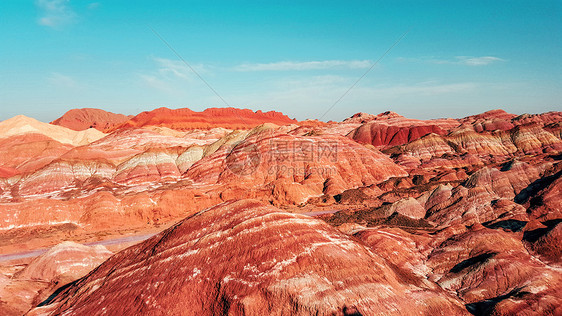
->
[234, 60, 372, 71]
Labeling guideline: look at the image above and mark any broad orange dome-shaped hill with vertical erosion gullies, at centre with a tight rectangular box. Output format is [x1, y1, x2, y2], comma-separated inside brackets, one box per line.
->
[186, 129, 407, 204]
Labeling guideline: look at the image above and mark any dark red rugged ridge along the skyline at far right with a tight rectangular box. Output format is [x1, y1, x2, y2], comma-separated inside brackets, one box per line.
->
[343, 110, 562, 154]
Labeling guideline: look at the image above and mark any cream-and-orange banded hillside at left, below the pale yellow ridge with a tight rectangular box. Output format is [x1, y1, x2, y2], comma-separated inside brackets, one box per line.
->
[0, 129, 228, 201]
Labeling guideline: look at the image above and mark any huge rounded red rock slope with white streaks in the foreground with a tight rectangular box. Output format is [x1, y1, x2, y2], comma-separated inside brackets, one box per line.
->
[31, 200, 468, 315]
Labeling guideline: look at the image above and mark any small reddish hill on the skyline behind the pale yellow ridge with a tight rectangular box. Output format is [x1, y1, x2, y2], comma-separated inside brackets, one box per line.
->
[51, 108, 131, 132]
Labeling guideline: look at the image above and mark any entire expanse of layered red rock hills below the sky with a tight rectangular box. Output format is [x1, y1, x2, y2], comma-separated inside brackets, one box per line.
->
[0, 108, 562, 315]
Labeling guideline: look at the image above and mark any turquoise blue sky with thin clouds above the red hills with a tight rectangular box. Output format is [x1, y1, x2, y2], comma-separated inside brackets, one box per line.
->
[0, 0, 562, 121]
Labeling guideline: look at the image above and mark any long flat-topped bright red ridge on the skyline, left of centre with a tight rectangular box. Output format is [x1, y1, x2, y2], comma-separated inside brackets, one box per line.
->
[106, 107, 298, 130]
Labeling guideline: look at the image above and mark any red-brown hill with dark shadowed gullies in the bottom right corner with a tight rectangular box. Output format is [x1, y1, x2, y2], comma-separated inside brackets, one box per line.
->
[427, 225, 562, 315]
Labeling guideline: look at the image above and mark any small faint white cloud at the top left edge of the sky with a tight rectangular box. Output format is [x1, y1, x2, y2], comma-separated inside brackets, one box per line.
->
[35, 0, 76, 28]
